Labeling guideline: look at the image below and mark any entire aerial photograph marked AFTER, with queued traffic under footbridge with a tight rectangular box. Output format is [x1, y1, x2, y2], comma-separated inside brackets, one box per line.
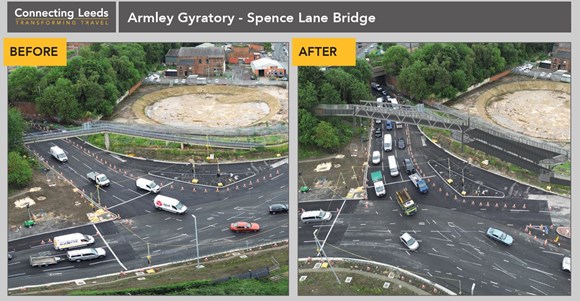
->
[295, 42, 572, 296]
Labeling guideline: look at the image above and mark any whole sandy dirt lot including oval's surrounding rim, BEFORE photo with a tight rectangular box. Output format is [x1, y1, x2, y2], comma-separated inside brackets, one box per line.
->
[109, 85, 288, 128]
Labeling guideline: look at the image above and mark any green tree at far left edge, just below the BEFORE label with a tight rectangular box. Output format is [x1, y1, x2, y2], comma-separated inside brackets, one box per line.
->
[8, 67, 41, 102]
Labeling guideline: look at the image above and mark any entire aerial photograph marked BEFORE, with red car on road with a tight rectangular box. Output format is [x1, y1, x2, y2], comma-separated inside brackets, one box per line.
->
[6, 42, 289, 296]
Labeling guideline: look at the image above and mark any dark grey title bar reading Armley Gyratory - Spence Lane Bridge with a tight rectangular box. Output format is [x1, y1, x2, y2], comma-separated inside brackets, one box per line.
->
[119, 1, 571, 33]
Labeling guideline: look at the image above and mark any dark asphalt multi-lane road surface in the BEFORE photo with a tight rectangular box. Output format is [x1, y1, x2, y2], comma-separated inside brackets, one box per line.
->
[8, 139, 288, 288]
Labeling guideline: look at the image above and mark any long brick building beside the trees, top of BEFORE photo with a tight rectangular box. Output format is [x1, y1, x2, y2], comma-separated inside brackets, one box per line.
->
[165, 47, 226, 77]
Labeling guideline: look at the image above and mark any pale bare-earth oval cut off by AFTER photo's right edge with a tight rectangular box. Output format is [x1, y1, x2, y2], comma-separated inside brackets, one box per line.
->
[486, 90, 571, 140]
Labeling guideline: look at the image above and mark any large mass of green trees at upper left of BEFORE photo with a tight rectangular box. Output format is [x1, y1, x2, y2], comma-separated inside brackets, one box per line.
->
[8, 43, 201, 123]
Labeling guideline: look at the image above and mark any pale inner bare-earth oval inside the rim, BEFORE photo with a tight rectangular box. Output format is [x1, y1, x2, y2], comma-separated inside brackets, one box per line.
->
[146, 93, 270, 128]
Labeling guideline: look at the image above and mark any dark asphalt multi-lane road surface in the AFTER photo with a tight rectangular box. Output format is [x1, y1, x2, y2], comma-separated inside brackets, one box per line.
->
[298, 114, 571, 295]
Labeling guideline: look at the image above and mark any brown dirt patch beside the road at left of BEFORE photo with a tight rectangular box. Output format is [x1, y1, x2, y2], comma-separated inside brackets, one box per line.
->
[8, 170, 92, 240]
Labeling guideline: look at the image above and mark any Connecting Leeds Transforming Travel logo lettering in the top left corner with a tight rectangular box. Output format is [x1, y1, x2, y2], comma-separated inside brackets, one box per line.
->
[14, 8, 109, 26]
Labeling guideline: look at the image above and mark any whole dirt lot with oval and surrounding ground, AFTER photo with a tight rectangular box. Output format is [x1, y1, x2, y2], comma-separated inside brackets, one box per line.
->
[446, 75, 571, 144]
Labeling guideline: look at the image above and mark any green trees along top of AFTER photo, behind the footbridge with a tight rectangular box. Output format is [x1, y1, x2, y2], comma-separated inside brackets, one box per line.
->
[383, 43, 553, 99]
